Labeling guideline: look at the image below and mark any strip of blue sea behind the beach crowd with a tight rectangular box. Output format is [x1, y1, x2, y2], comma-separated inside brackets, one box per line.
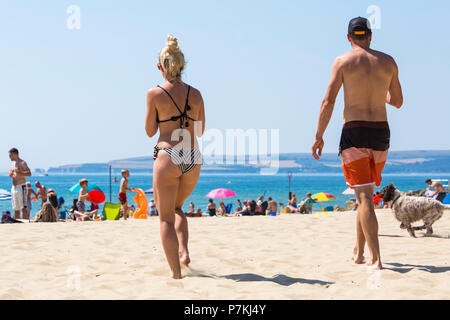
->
[0, 174, 449, 217]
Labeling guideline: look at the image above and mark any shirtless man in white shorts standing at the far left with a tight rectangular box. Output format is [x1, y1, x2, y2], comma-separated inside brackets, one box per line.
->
[8, 148, 31, 219]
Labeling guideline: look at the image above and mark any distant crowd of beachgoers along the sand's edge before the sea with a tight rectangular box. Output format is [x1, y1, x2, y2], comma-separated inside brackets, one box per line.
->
[2, 170, 447, 222]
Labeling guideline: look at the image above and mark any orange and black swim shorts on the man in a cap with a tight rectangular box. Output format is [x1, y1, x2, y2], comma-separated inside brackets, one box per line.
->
[339, 121, 390, 188]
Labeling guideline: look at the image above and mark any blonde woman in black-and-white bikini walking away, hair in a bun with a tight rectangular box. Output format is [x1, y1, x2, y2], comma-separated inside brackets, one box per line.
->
[145, 35, 205, 279]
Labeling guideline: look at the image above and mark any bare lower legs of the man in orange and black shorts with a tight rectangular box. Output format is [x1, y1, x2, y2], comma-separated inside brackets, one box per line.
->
[355, 185, 382, 269]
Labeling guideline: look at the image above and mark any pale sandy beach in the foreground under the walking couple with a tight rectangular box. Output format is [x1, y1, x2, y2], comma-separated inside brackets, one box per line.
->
[0, 209, 450, 299]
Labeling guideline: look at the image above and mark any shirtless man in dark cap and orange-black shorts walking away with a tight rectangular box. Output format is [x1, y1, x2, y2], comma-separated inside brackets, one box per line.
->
[312, 17, 403, 269]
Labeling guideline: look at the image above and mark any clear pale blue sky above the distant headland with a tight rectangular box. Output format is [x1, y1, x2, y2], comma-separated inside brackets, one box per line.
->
[0, 0, 450, 171]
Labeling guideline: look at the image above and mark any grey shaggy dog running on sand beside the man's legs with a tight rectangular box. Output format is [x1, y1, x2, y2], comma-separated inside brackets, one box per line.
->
[381, 184, 449, 237]
